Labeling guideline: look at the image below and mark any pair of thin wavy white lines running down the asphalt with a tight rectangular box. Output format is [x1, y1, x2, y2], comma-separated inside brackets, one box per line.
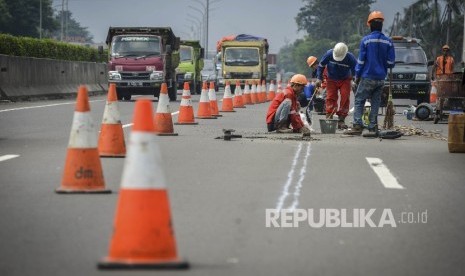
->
[276, 143, 311, 211]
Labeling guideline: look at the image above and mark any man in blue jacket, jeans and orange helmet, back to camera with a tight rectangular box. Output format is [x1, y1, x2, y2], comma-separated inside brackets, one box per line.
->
[344, 11, 396, 135]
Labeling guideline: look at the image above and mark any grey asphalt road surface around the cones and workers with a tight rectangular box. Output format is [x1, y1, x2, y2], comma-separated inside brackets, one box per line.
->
[0, 89, 465, 275]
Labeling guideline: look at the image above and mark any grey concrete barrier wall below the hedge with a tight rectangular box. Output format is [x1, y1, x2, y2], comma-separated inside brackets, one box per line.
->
[0, 55, 108, 100]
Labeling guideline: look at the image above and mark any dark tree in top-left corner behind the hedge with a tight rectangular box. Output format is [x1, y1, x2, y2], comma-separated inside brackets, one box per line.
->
[0, 0, 57, 37]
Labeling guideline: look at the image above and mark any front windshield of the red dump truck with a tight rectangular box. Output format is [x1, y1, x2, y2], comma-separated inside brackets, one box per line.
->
[111, 36, 160, 57]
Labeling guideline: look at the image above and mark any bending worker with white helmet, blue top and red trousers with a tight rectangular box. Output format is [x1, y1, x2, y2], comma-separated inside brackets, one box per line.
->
[316, 42, 357, 129]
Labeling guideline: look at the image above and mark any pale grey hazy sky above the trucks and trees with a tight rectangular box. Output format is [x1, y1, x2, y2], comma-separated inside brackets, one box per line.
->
[53, 0, 415, 53]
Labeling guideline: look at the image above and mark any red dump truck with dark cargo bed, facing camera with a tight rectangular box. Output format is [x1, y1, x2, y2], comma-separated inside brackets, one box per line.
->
[106, 27, 180, 101]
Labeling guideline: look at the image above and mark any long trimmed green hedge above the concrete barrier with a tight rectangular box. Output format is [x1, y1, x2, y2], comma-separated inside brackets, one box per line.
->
[0, 34, 107, 62]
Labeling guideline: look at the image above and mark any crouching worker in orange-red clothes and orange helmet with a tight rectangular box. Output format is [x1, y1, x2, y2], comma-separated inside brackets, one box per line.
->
[266, 74, 310, 135]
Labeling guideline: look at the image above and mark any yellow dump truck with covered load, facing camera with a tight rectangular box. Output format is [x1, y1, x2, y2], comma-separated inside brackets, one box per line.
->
[217, 35, 269, 91]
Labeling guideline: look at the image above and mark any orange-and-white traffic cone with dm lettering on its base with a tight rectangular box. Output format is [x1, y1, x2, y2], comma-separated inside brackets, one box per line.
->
[55, 85, 111, 194]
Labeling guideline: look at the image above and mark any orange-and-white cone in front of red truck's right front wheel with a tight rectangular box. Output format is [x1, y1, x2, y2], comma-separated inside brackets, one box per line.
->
[155, 83, 178, 136]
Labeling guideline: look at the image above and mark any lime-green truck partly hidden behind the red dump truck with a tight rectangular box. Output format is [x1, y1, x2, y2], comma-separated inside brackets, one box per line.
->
[176, 40, 205, 94]
